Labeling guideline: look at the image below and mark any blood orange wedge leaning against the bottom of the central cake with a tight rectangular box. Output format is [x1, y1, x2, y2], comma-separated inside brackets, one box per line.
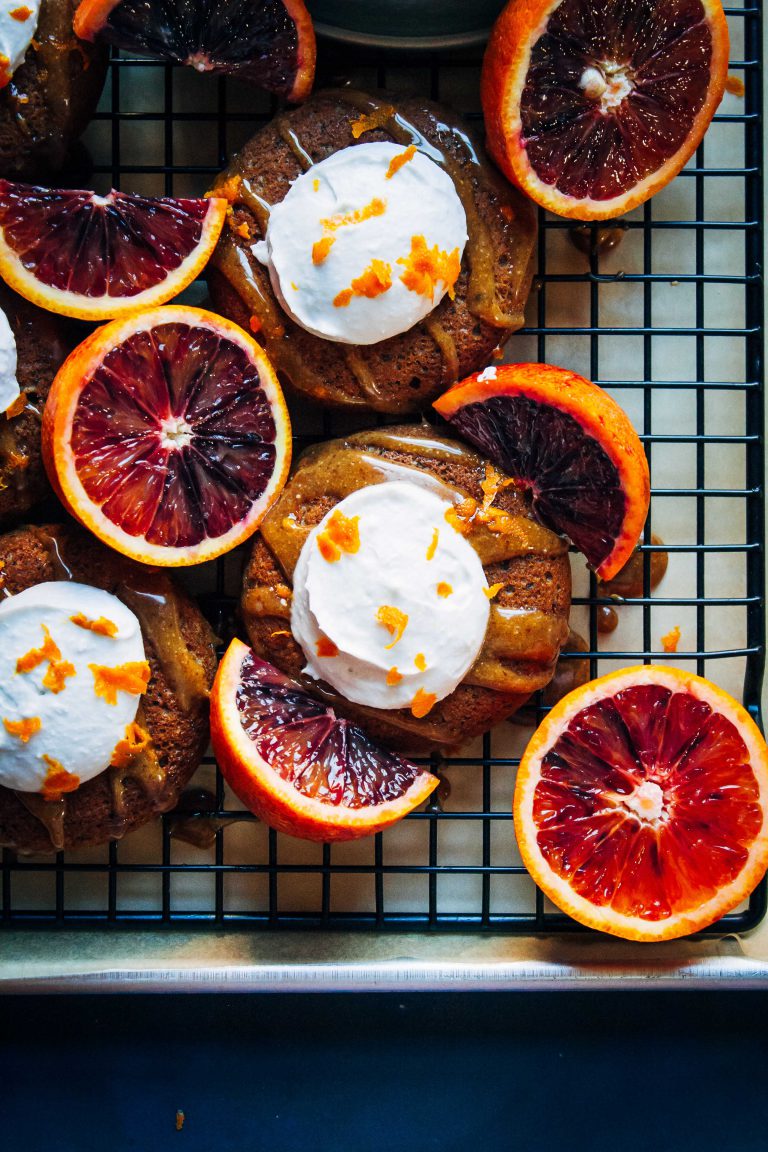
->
[211, 641, 439, 841]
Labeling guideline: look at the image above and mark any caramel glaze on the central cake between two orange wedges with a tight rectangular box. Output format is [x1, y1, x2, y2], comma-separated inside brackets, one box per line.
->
[243, 425, 568, 705]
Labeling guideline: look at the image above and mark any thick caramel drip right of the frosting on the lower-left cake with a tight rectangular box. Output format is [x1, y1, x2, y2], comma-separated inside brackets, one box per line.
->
[117, 585, 208, 712]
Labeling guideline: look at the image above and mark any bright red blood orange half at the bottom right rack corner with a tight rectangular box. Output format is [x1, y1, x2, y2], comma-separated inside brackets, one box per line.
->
[515, 666, 768, 940]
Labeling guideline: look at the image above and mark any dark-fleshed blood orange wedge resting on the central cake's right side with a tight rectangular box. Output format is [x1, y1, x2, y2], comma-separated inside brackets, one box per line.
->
[434, 364, 651, 581]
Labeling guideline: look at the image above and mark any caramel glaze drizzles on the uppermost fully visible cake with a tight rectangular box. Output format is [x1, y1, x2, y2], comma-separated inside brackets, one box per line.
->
[212, 89, 522, 400]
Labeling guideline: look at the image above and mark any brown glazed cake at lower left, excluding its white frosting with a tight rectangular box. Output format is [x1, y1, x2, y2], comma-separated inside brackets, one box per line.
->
[0, 525, 215, 852]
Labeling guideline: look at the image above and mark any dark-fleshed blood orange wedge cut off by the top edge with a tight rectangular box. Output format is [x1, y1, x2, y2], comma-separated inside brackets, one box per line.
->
[75, 0, 315, 103]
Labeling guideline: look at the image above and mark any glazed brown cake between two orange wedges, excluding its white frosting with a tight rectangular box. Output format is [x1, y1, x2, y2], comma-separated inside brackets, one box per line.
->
[242, 424, 571, 753]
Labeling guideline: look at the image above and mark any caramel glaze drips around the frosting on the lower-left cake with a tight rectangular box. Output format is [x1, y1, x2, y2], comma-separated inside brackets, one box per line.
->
[15, 528, 208, 851]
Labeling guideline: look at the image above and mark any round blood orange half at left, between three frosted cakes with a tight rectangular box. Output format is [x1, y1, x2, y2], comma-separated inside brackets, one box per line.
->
[43, 305, 290, 566]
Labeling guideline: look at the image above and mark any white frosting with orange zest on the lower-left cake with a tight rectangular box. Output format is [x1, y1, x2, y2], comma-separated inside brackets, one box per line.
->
[0, 581, 144, 791]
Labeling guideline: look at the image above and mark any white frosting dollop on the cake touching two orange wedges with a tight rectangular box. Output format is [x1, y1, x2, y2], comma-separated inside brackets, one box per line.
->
[291, 480, 489, 715]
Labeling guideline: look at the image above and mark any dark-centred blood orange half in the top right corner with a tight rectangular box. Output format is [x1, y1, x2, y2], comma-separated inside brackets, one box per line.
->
[482, 0, 729, 220]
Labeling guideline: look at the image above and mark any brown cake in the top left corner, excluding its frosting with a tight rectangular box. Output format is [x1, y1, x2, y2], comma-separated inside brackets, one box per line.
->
[0, 0, 108, 180]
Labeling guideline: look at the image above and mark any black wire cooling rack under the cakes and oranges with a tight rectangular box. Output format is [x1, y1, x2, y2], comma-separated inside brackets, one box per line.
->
[1, 6, 766, 933]
